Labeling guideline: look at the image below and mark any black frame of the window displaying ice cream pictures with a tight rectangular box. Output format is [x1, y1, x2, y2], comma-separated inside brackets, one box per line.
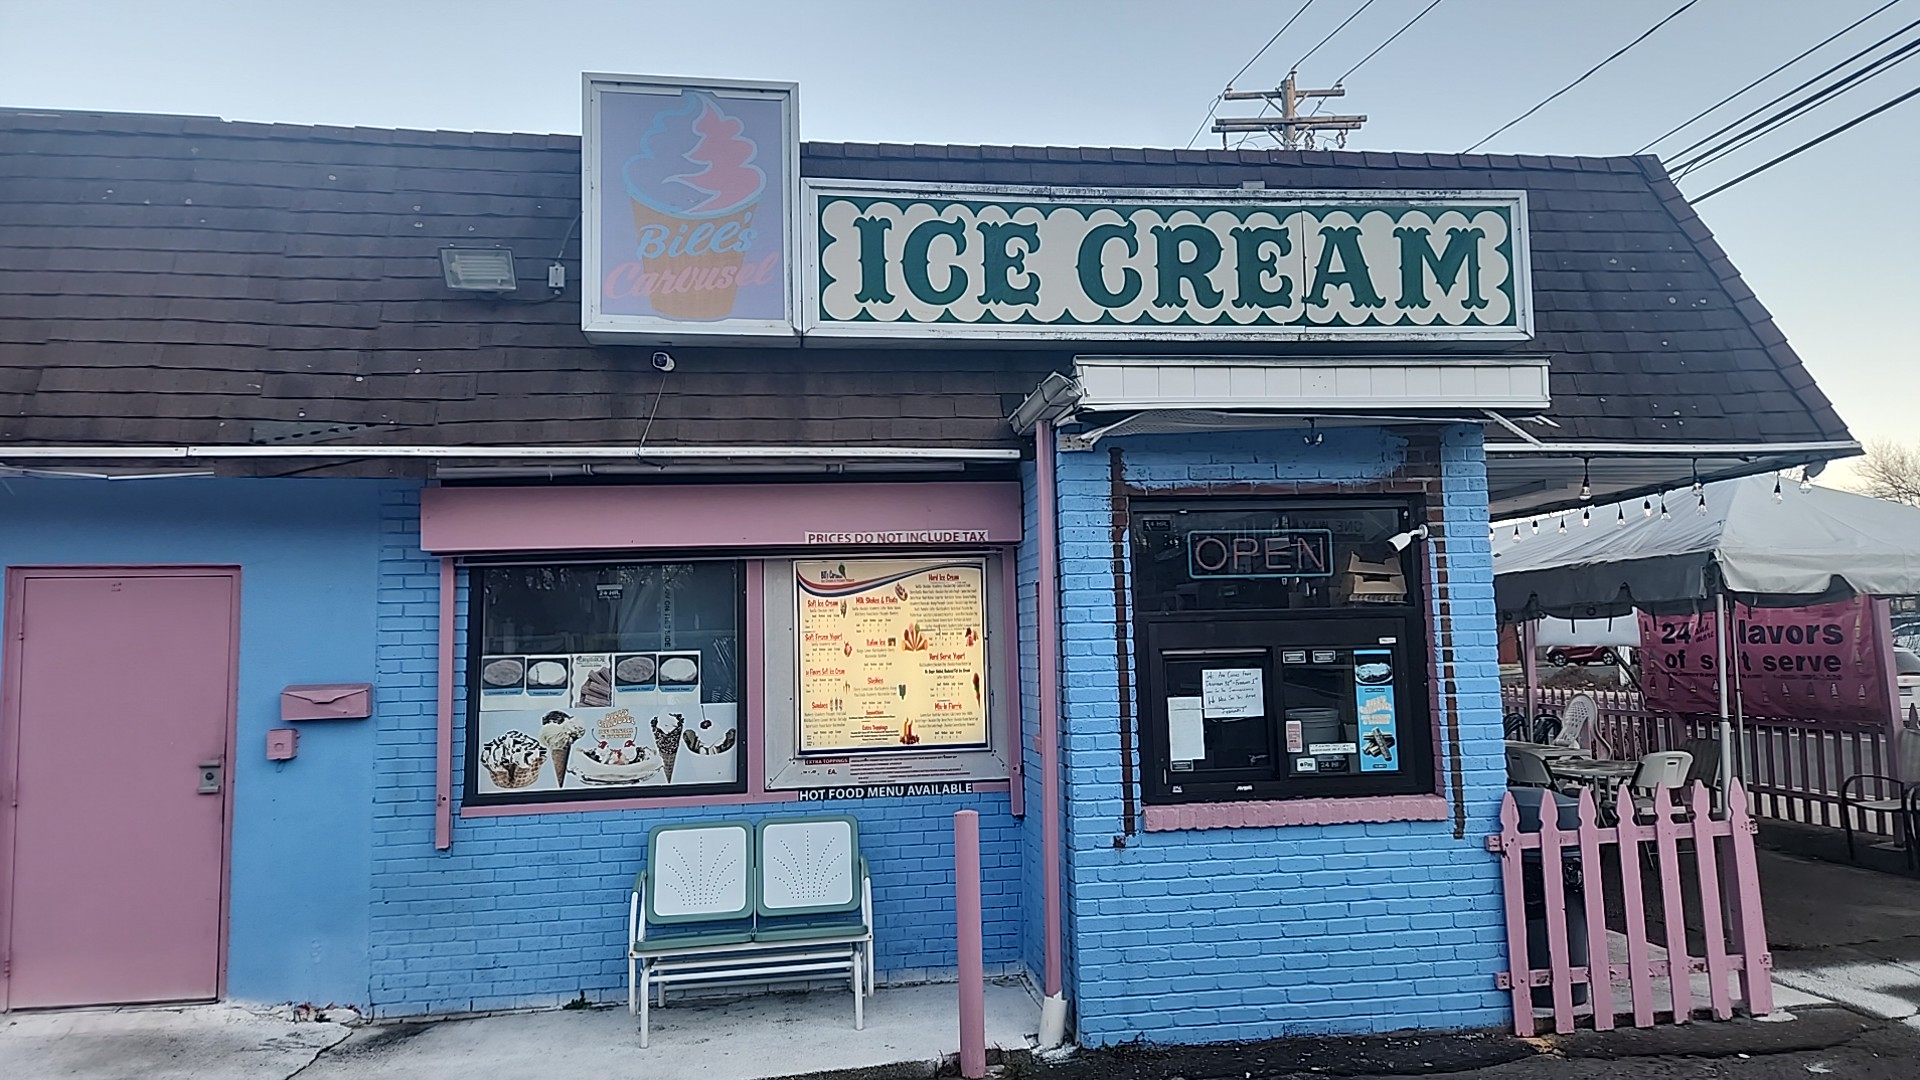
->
[461, 552, 762, 807]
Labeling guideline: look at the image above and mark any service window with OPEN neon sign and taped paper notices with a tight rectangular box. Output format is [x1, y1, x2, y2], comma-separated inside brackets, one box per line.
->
[1131, 500, 1432, 803]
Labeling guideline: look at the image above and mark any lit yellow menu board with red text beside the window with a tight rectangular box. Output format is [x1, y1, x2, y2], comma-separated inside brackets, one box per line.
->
[793, 559, 989, 755]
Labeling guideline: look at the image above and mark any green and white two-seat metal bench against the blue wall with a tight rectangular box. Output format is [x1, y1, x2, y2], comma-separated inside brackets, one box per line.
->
[626, 817, 874, 1047]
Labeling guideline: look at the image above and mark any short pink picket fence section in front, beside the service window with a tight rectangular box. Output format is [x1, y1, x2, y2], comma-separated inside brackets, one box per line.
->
[1486, 780, 1774, 1036]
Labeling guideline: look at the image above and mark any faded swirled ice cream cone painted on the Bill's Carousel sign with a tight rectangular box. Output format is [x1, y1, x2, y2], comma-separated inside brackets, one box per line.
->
[626, 90, 760, 319]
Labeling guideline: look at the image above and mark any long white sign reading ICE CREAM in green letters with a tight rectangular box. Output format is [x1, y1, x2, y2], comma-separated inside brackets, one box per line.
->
[803, 181, 1532, 340]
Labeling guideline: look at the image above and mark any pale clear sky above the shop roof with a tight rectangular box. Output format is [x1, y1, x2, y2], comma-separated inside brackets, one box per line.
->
[0, 0, 1920, 477]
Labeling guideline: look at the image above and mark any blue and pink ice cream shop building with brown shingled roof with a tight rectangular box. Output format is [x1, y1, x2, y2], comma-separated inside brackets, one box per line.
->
[0, 77, 1853, 1043]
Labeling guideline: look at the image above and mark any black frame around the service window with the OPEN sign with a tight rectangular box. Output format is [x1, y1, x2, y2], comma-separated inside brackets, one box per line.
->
[1127, 494, 1438, 805]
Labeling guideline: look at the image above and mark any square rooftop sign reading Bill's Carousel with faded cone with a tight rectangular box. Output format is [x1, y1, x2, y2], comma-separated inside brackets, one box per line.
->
[582, 75, 799, 342]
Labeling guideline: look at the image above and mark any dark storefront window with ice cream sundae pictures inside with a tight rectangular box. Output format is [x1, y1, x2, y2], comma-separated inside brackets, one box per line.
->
[467, 561, 745, 803]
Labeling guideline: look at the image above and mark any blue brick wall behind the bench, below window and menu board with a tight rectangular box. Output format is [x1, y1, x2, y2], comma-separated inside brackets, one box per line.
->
[369, 488, 1027, 1017]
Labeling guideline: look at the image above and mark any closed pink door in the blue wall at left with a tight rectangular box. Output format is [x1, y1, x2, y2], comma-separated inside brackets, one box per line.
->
[0, 569, 238, 1009]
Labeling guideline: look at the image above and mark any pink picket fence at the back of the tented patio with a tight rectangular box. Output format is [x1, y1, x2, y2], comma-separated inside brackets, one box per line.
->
[1501, 686, 1920, 836]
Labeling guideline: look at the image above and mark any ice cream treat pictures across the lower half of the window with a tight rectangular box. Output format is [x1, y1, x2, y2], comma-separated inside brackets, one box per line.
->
[474, 650, 739, 796]
